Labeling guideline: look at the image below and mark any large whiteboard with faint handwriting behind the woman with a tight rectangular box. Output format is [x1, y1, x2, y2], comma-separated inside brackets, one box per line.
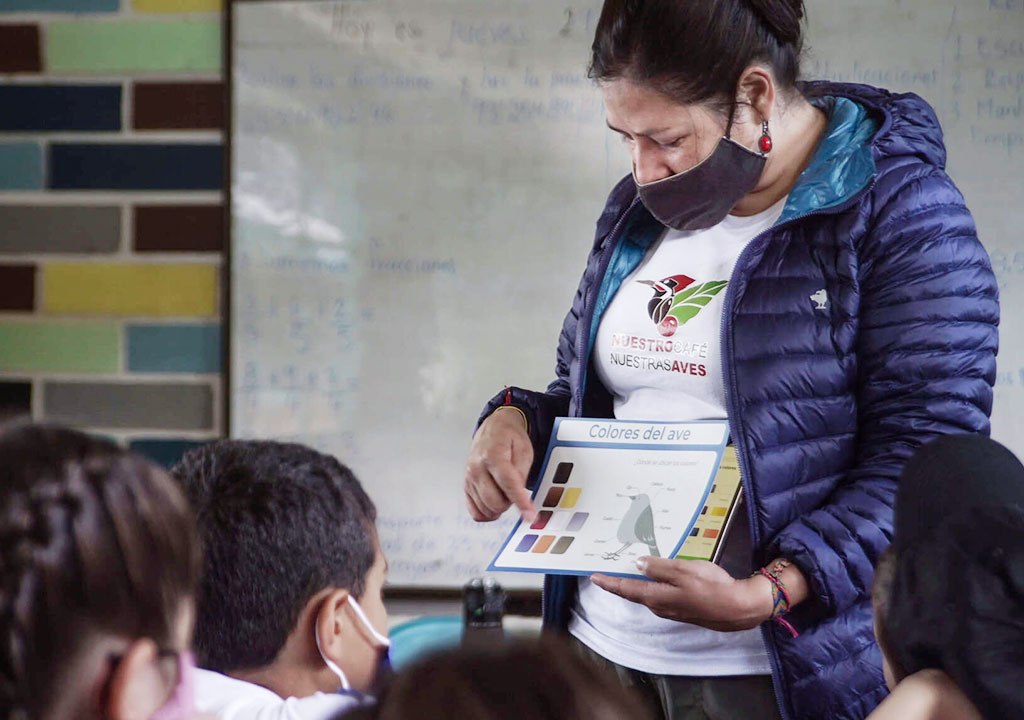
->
[228, 0, 1024, 587]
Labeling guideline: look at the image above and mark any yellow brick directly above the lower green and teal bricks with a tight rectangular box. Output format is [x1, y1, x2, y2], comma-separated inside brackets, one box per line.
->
[42, 262, 217, 317]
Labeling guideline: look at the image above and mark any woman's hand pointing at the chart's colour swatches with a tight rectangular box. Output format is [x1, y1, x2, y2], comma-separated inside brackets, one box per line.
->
[465, 406, 537, 522]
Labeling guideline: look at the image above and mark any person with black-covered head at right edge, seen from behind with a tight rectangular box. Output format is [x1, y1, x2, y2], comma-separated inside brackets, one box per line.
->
[870, 435, 1024, 720]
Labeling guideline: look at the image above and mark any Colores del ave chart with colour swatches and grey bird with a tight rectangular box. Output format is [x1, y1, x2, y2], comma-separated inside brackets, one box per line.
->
[488, 418, 729, 577]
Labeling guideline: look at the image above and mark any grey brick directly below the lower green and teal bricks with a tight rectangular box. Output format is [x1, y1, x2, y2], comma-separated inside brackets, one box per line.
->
[43, 382, 213, 430]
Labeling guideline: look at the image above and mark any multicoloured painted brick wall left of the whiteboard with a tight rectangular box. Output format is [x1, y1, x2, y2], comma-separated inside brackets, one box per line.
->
[0, 0, 224, 464]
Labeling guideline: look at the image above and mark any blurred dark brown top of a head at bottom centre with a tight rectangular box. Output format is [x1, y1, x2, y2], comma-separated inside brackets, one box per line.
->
[345, 637, 650, 720]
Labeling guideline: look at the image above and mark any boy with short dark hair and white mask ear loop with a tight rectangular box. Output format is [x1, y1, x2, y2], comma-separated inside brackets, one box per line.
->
[172, 440, 389, 720]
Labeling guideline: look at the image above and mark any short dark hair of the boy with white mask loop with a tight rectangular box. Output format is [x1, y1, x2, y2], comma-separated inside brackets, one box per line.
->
[171, 440, 377, 672]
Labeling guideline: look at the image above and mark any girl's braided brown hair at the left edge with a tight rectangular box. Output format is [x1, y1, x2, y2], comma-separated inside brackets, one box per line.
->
[0, 425, 200, 719]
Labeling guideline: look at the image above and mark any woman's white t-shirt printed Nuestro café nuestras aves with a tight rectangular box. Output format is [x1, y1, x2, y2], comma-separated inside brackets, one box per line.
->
[569, 198, 785, 676]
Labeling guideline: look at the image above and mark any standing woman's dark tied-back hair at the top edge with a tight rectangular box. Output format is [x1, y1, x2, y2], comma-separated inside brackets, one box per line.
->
[589, 0, 804, 108]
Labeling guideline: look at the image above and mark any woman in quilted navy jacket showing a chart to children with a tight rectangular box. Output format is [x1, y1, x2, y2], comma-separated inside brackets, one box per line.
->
[465, 0, 998, 720]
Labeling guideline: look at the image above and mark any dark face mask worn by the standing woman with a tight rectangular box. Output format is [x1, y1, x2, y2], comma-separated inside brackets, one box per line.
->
[633, 107, 767, 230]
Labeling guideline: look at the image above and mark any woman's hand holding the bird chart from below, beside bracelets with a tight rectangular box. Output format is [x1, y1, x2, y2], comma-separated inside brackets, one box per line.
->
[591, 557, 772, 632]
